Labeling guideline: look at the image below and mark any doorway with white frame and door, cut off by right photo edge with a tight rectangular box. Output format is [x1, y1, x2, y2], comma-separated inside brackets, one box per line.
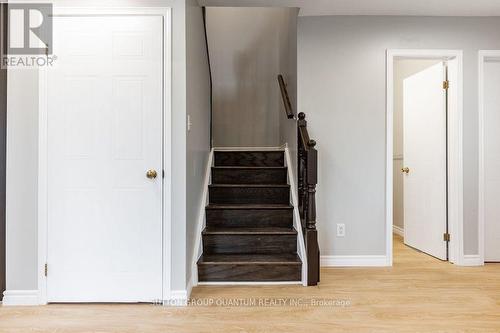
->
[479, 50, 500, 263]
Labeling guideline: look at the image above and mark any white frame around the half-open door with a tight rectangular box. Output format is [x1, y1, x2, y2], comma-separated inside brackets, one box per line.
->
[385, 49, 464, 265]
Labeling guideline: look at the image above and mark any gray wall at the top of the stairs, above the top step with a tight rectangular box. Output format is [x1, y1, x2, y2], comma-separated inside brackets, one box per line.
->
[207, 7, 296, 147]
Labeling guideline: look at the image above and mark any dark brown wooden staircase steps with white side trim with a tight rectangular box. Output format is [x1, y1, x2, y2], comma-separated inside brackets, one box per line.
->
[198, 151, 302, 282]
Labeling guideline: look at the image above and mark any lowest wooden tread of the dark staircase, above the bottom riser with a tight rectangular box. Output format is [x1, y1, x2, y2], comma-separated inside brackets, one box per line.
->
[198, 253, 302, 265]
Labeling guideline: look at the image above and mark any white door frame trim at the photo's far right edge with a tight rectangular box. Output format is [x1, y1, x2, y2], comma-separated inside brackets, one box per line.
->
[478, 50, 500, 265]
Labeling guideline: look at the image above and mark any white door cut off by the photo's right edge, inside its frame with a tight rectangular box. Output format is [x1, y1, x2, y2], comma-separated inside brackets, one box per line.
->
[483, 60, 500, 262]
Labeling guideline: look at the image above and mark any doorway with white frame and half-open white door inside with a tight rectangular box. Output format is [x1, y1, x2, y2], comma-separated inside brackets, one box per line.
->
[386, 50, 463, 263]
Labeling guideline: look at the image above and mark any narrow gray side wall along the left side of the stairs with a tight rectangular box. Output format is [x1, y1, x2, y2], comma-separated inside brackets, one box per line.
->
[186, 0, 210, 281]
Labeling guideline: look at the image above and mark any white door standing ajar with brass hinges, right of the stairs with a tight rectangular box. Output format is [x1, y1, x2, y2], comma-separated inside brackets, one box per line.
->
[403, 63, 447, 260]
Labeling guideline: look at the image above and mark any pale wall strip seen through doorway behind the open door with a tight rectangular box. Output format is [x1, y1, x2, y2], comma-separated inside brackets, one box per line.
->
[392, 59, 442, 229]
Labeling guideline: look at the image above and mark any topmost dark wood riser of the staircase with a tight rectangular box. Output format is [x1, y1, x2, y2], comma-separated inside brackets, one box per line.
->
[214, 151, 285, 166]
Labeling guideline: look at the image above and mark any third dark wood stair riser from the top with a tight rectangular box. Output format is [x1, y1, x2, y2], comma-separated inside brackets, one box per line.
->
[208, 184, 290, 204]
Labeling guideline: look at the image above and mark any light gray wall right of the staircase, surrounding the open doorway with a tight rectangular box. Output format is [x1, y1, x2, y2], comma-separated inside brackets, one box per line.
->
[298, 16, 500, 255]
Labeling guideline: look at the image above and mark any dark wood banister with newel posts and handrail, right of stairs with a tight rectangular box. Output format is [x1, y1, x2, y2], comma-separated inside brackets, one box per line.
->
[278, 75, 320, 286]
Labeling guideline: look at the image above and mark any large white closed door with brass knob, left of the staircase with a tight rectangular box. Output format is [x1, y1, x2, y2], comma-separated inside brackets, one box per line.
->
[47, 16, 163, 302]
